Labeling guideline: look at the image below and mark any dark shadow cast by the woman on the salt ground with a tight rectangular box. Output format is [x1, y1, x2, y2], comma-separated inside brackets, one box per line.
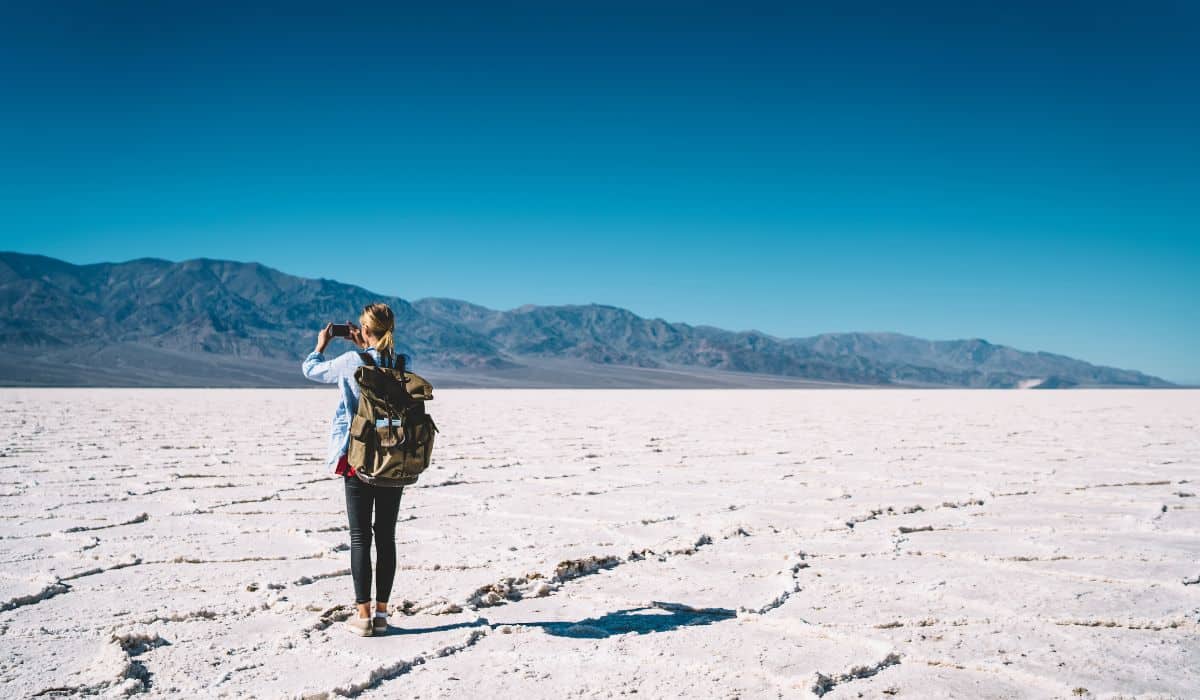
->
[389, 600, 738, 639]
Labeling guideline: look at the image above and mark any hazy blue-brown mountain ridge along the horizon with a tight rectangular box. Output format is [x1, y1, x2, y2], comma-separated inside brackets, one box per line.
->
[0, 252, 1171, 388]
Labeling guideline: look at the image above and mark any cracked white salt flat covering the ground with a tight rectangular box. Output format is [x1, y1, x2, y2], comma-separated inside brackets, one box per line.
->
[0, 389, 1200, 698]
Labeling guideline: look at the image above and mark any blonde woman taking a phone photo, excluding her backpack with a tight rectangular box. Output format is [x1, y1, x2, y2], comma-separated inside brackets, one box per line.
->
[302, 304, 407, 636]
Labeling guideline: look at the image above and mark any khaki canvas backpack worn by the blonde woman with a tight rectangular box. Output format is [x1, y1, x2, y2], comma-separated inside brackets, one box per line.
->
[346, 353, 438, 486]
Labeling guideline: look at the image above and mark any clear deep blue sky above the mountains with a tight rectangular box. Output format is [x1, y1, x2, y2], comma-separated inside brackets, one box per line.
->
[0, 2, 1200, 382]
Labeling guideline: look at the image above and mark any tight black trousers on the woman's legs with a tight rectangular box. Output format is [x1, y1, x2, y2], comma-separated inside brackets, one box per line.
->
[342, 475, 404, 604]
